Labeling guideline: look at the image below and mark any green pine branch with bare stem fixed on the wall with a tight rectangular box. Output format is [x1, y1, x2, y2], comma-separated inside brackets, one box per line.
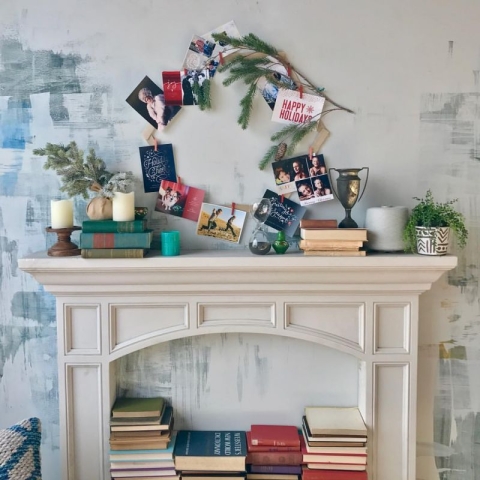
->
[194, 33, 354, 170]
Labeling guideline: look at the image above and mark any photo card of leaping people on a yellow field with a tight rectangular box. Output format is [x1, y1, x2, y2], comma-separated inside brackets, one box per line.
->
[197, 203, 247, 243]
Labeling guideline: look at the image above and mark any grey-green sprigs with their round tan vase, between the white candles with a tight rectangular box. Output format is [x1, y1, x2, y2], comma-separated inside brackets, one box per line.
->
[33, 142, 134, 220]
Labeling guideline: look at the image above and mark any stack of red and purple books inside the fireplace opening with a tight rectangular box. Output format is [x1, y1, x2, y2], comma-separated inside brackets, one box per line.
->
[247, 425, 303, 480]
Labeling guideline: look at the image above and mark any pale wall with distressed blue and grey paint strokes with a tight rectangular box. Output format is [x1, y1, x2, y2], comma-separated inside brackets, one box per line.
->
[0, 0, 480, 480]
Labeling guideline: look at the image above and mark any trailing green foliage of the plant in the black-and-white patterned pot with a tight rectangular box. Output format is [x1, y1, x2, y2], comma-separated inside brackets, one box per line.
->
[403, 190, 468, 252]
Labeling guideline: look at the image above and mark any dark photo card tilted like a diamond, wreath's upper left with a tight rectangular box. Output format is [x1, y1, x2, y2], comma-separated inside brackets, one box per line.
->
[126, 76, 181, 130]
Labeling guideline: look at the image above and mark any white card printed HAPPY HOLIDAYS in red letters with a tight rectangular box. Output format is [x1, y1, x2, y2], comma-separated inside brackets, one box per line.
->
[272, 88, 325, 124]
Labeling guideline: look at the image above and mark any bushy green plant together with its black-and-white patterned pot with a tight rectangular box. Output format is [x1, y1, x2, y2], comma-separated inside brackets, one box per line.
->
[403, 190, 468, 255]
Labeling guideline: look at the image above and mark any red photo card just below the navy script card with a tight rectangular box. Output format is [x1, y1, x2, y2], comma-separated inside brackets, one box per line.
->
[155, 180, 205, 222]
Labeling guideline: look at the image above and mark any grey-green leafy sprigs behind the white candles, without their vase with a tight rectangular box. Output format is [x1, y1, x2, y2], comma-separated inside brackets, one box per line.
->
[33, 142, 132, 199]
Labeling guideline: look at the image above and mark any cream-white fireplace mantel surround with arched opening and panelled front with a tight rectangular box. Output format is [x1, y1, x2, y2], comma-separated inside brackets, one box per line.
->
[19, 251, 457, 480]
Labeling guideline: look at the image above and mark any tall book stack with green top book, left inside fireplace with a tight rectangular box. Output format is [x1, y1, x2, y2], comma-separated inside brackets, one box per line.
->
[110, 397, 179, 480]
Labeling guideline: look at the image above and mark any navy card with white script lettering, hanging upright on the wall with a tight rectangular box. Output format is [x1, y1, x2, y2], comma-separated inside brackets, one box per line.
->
[139, 143, 177, 193]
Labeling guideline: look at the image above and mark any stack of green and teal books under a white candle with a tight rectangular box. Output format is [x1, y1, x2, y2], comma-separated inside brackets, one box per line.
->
[80, 220, 153, 258]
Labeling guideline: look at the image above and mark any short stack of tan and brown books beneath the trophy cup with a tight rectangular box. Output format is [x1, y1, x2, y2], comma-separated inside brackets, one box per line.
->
[299, 220, 367, 257]
